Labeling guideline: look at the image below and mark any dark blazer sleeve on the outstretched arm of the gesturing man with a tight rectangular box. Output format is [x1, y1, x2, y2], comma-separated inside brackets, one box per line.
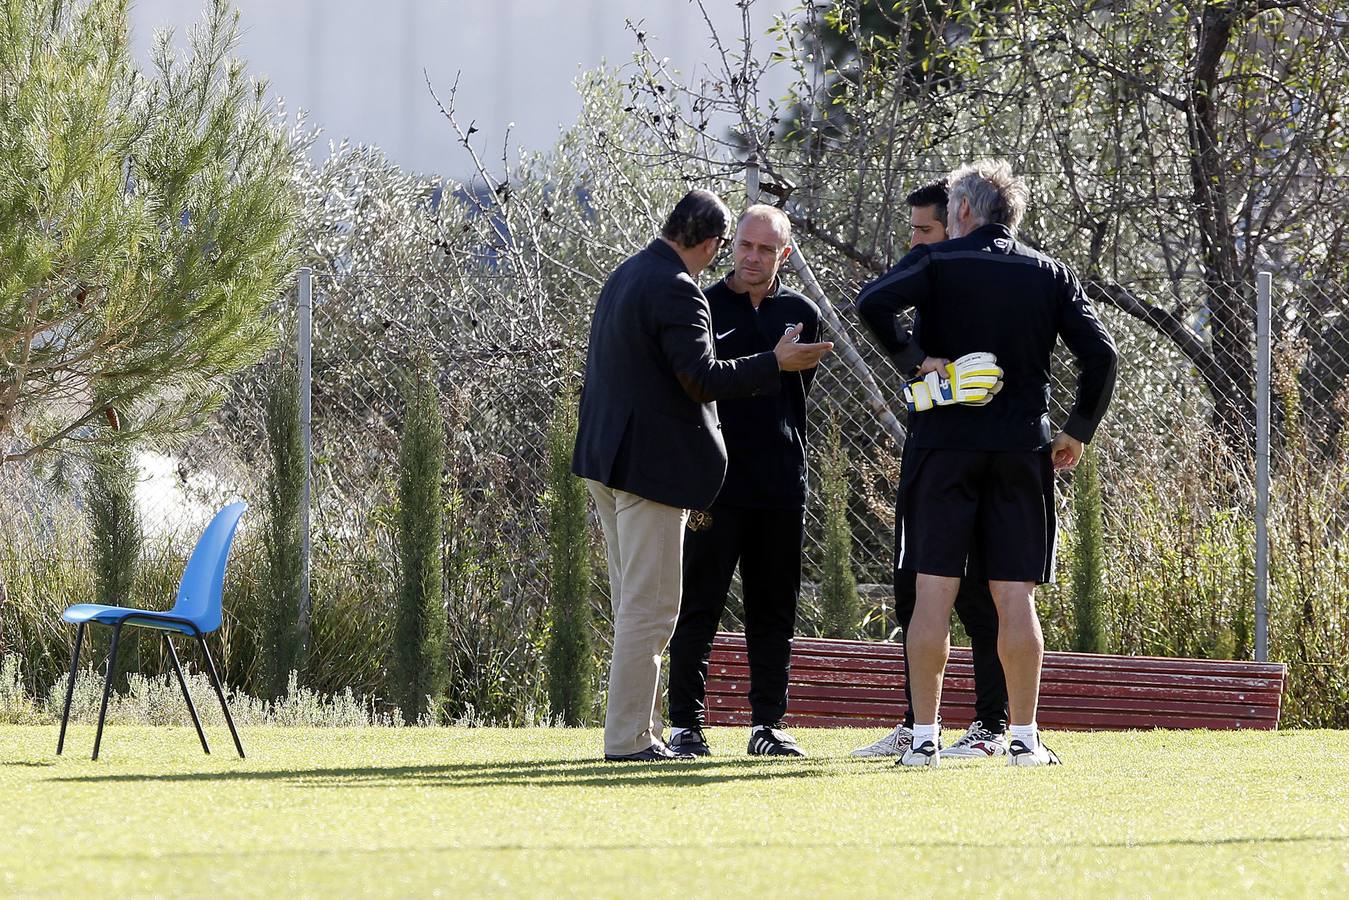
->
[654, 275, 781, 403]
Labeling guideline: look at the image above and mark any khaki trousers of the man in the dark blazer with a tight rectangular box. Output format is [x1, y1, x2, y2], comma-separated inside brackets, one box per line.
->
[585, 479, 688, 756]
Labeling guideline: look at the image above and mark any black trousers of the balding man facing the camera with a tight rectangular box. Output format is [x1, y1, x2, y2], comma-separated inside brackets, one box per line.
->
[669, 503, 805, 729]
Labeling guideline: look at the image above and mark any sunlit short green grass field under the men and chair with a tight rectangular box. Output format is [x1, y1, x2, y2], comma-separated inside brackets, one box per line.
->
[0, 726, 1349, 897]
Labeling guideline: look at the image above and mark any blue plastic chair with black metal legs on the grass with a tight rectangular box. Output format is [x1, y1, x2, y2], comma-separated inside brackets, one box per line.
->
[57, 503, 248, 760]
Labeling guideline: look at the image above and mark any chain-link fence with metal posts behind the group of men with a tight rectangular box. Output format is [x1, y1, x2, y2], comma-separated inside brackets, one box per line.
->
[5, 244, 1349, 721]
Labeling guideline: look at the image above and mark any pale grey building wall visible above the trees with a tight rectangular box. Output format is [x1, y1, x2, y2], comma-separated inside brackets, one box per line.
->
[131, 0, 795, 177]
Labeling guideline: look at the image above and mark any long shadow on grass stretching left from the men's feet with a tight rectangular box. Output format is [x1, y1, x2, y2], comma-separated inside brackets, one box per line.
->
[51, 760, 824, 788]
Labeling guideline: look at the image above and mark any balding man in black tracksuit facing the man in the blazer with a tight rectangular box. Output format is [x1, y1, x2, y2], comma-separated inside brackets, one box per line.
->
[669, 205, 820, 756]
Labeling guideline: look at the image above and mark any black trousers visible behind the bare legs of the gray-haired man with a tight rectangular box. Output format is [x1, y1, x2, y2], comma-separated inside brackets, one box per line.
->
[894, 569, 1008, 731]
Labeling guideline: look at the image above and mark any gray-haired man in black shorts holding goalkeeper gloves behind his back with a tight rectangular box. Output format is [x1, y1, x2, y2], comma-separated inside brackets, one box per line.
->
[857, 159, 1117, 765]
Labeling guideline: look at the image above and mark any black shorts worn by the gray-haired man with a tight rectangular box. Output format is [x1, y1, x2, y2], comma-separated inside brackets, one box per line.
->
[898, 449, 1058, 584]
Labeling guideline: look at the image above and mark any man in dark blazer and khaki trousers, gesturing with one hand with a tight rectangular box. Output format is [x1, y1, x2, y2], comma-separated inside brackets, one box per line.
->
[572, 190, 834, 761]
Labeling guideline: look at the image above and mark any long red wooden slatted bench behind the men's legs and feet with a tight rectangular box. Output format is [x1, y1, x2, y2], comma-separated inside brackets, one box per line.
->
[707, 631, 1287, 731]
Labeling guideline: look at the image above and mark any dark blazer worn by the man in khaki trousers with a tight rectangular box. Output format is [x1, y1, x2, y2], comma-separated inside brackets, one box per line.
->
[572, 240, 780, 509]
